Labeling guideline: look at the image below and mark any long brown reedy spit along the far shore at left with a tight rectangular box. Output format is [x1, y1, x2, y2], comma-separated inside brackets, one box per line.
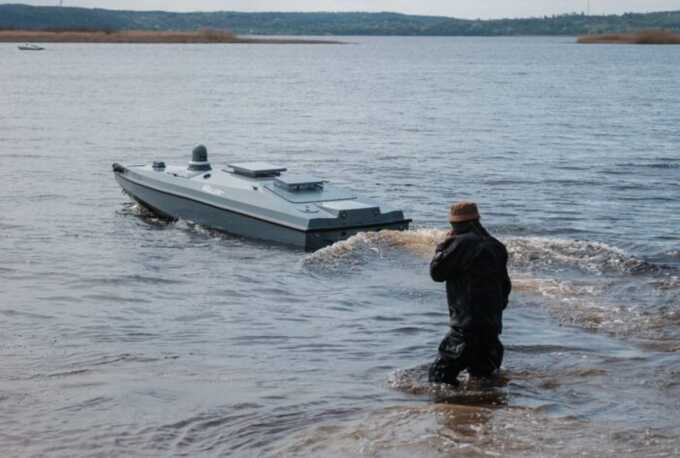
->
[0, 30, 341, 44]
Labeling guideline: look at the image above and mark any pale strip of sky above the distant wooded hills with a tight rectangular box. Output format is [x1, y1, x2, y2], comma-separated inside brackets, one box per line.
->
[9, 0, 680, 18]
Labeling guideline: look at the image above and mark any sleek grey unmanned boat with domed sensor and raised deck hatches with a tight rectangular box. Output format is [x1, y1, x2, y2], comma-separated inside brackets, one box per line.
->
[113, 146, 411, 251]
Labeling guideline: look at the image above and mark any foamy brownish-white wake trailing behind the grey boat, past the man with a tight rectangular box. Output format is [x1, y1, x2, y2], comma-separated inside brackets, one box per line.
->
[303, 229, 680, 348]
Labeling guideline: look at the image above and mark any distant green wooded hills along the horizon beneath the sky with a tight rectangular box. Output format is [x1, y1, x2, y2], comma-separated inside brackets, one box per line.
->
[0, 4, 680, 36]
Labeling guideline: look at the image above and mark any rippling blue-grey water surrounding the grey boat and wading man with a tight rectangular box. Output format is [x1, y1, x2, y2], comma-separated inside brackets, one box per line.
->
[0, 38, 680, 457]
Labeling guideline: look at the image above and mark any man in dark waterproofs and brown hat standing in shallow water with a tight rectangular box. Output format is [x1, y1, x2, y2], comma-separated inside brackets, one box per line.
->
[429, 202, 512, 385]
